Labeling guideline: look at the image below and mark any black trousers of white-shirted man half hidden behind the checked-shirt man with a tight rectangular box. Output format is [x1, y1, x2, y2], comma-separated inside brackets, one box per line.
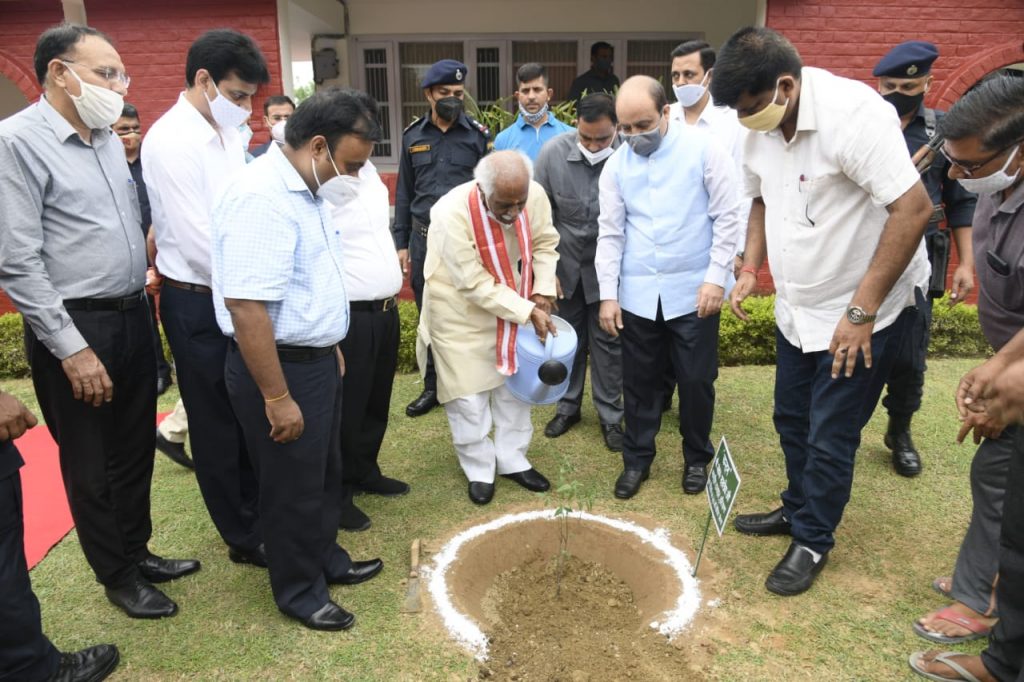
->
[341, 308, 400, 504]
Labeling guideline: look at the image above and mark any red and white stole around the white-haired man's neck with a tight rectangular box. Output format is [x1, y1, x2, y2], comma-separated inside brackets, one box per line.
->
[469, 185, 534, 377]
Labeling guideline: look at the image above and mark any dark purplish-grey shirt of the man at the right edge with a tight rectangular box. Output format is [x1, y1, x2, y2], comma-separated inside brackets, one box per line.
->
[974, 182, 1024, 350]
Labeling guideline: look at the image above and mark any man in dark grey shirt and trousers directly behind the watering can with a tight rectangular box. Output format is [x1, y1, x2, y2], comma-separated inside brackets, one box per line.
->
[536, 92, 623, 453]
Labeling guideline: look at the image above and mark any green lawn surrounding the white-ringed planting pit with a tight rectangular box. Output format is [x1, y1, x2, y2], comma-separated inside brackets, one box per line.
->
[4, 360, 983, 680]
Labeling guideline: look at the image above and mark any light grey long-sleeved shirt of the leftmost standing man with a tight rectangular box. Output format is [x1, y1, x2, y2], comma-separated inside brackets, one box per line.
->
[0, 96, 145, 359]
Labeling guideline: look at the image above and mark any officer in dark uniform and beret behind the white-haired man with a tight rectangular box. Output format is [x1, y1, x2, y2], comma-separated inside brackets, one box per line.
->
[391, 59, 488, 417]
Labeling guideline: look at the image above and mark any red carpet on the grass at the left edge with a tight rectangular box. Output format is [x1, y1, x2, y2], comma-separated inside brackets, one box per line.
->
[16, 424, 75, 568]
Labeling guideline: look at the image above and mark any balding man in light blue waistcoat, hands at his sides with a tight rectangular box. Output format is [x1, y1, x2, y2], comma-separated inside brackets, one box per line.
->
[594, 76, 740, 500]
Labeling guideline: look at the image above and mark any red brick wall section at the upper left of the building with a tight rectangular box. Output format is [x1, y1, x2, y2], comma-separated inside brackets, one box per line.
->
[0, 0, 282, 313]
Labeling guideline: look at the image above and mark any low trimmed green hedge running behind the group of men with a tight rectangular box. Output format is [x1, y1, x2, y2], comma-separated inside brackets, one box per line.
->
[0, 296, 992, 379]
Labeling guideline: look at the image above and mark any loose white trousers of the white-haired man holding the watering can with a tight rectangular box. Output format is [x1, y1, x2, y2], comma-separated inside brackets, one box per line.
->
[444, 384, 534, 483]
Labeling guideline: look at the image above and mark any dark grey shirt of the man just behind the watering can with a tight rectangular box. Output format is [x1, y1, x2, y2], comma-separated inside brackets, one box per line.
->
[534, 130, 620, 303]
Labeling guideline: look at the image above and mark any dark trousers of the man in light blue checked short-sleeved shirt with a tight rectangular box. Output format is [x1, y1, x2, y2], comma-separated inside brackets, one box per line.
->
[224, 343, 351, 621]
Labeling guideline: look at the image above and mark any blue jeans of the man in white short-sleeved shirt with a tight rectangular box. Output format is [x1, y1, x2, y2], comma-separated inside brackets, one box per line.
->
[774, 308, 915, 553]
